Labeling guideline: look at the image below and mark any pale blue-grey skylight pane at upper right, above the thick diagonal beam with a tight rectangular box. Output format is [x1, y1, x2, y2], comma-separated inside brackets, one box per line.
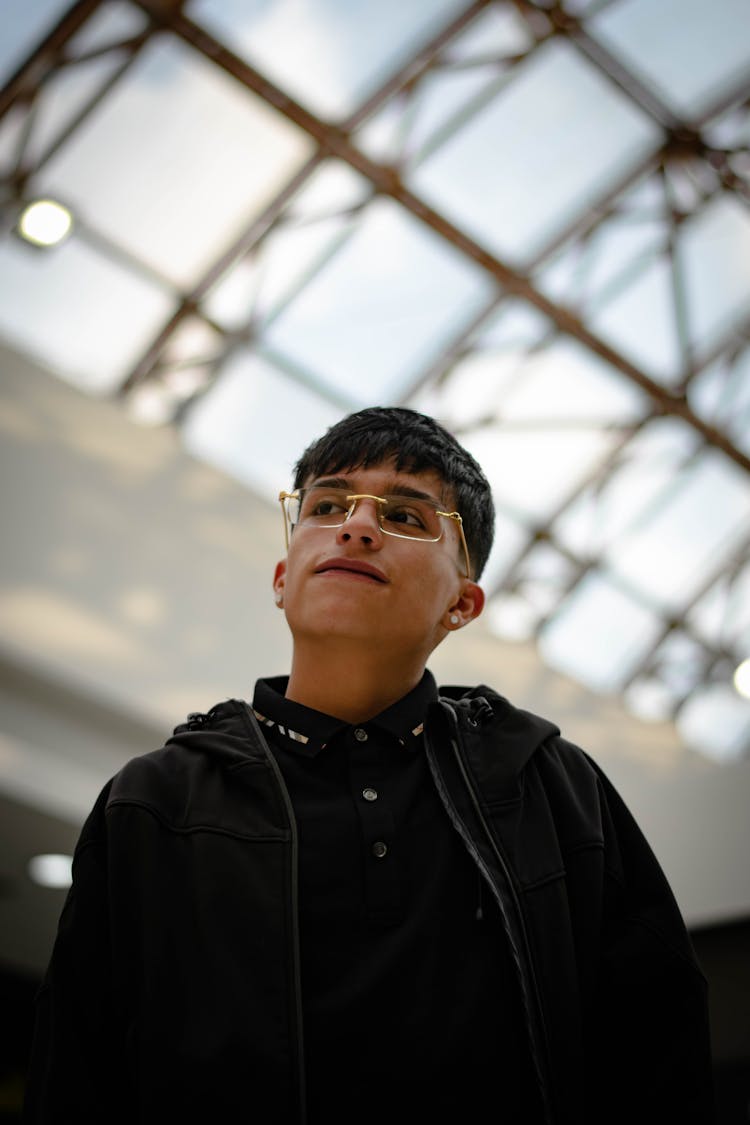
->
[408, 42, 660, 263]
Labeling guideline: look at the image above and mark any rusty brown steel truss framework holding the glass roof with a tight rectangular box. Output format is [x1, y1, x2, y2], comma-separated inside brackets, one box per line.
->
[0, 0, 750, 733]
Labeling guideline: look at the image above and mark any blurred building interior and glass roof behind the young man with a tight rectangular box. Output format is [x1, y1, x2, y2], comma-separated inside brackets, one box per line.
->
[0, 0, 750, 1123]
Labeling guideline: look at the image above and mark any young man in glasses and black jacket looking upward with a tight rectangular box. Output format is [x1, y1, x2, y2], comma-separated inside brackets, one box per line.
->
[27, 408, 712, 1125]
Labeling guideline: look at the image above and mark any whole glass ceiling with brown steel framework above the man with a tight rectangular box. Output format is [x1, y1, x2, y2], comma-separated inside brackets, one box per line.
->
[0, 0, 750, 758]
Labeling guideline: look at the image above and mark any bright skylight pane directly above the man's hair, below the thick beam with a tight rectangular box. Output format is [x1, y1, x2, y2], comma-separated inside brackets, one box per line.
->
[266, 199, 495, 405]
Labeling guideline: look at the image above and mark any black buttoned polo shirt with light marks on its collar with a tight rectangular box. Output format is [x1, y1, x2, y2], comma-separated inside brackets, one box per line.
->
[253, 672, 536, 1125]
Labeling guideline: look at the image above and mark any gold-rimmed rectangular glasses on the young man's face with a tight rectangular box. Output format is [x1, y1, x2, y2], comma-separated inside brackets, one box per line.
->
[279, 485, 471, 577]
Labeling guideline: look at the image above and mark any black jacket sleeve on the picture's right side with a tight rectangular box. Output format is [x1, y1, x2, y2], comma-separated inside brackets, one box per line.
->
[587, 765, 714, 1125]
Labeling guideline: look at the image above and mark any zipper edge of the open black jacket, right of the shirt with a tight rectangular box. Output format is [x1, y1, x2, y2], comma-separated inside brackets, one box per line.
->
[425, 700, 554, 1125]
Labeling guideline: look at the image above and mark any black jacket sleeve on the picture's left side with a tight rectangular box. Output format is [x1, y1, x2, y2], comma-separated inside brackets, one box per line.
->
[24, 785, 121, 1125]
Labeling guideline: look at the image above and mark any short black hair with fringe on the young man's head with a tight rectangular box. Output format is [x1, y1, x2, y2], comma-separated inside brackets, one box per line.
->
[295, 406, 495, 579]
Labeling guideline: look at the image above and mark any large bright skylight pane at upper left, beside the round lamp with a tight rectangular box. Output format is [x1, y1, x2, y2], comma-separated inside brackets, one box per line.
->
[31, 38, 311, 286]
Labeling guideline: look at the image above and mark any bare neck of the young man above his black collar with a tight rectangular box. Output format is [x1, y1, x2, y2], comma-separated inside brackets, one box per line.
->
[286, 646, 424, 722]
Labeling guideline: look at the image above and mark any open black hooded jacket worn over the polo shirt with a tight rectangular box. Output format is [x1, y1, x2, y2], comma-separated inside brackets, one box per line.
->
[26, 686, 713, 1125]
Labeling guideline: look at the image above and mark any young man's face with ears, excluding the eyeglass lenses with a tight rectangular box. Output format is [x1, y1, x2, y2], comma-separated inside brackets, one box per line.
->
[274, 462, 484, 659]
